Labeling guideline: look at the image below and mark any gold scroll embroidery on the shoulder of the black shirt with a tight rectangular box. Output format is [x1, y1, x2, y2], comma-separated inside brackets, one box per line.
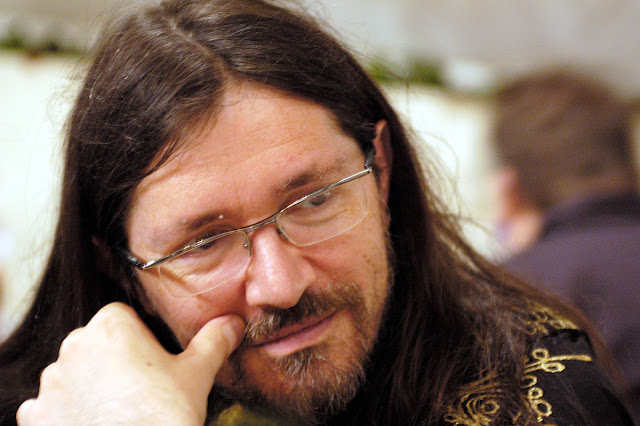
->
[444, 306, 592, 426]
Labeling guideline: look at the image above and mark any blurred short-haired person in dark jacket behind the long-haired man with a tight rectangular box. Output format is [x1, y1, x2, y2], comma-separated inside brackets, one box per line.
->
[495, 71, 640, 422]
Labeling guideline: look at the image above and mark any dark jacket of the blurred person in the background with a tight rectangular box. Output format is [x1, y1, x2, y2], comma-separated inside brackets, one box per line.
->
[506, 194, 640, 423]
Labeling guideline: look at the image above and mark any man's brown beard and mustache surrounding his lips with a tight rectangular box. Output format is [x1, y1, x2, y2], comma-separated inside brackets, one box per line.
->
[216, 283, 386, 423]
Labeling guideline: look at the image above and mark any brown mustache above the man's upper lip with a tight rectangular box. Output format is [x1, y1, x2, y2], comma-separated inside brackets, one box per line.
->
[240, 283, 364, 348]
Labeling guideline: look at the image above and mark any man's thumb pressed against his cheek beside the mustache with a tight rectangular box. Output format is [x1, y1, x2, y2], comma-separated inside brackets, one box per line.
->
[178, 315, 245, 392]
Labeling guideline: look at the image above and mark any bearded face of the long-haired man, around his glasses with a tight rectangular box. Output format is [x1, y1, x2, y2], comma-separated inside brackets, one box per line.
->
[126, 83, 390, 414]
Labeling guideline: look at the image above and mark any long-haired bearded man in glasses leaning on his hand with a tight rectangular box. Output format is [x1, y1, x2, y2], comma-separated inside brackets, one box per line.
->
[0, 0, 626, 425]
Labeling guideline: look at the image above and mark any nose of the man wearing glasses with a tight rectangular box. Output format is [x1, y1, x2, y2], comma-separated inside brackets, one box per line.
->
[245, 225, 316, 309]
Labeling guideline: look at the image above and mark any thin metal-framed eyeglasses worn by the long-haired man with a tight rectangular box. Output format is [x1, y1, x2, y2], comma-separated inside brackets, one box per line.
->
[116, 145, 375, 297]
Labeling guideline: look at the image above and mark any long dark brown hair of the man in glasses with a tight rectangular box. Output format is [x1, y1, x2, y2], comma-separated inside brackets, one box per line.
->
[0, 0, 604, 424]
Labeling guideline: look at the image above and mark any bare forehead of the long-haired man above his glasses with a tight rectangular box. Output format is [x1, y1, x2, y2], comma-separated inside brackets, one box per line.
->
[127, 83, 359, 240]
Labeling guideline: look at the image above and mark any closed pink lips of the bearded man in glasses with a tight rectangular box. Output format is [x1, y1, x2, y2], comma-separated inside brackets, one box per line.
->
[252, 312, 335, 357]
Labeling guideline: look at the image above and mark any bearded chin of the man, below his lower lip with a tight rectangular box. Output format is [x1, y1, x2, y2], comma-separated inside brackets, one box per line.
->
[216, 322, 373, 423]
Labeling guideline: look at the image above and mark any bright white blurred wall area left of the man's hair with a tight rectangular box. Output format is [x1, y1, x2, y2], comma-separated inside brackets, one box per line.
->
[0, 50, 73, 336]
